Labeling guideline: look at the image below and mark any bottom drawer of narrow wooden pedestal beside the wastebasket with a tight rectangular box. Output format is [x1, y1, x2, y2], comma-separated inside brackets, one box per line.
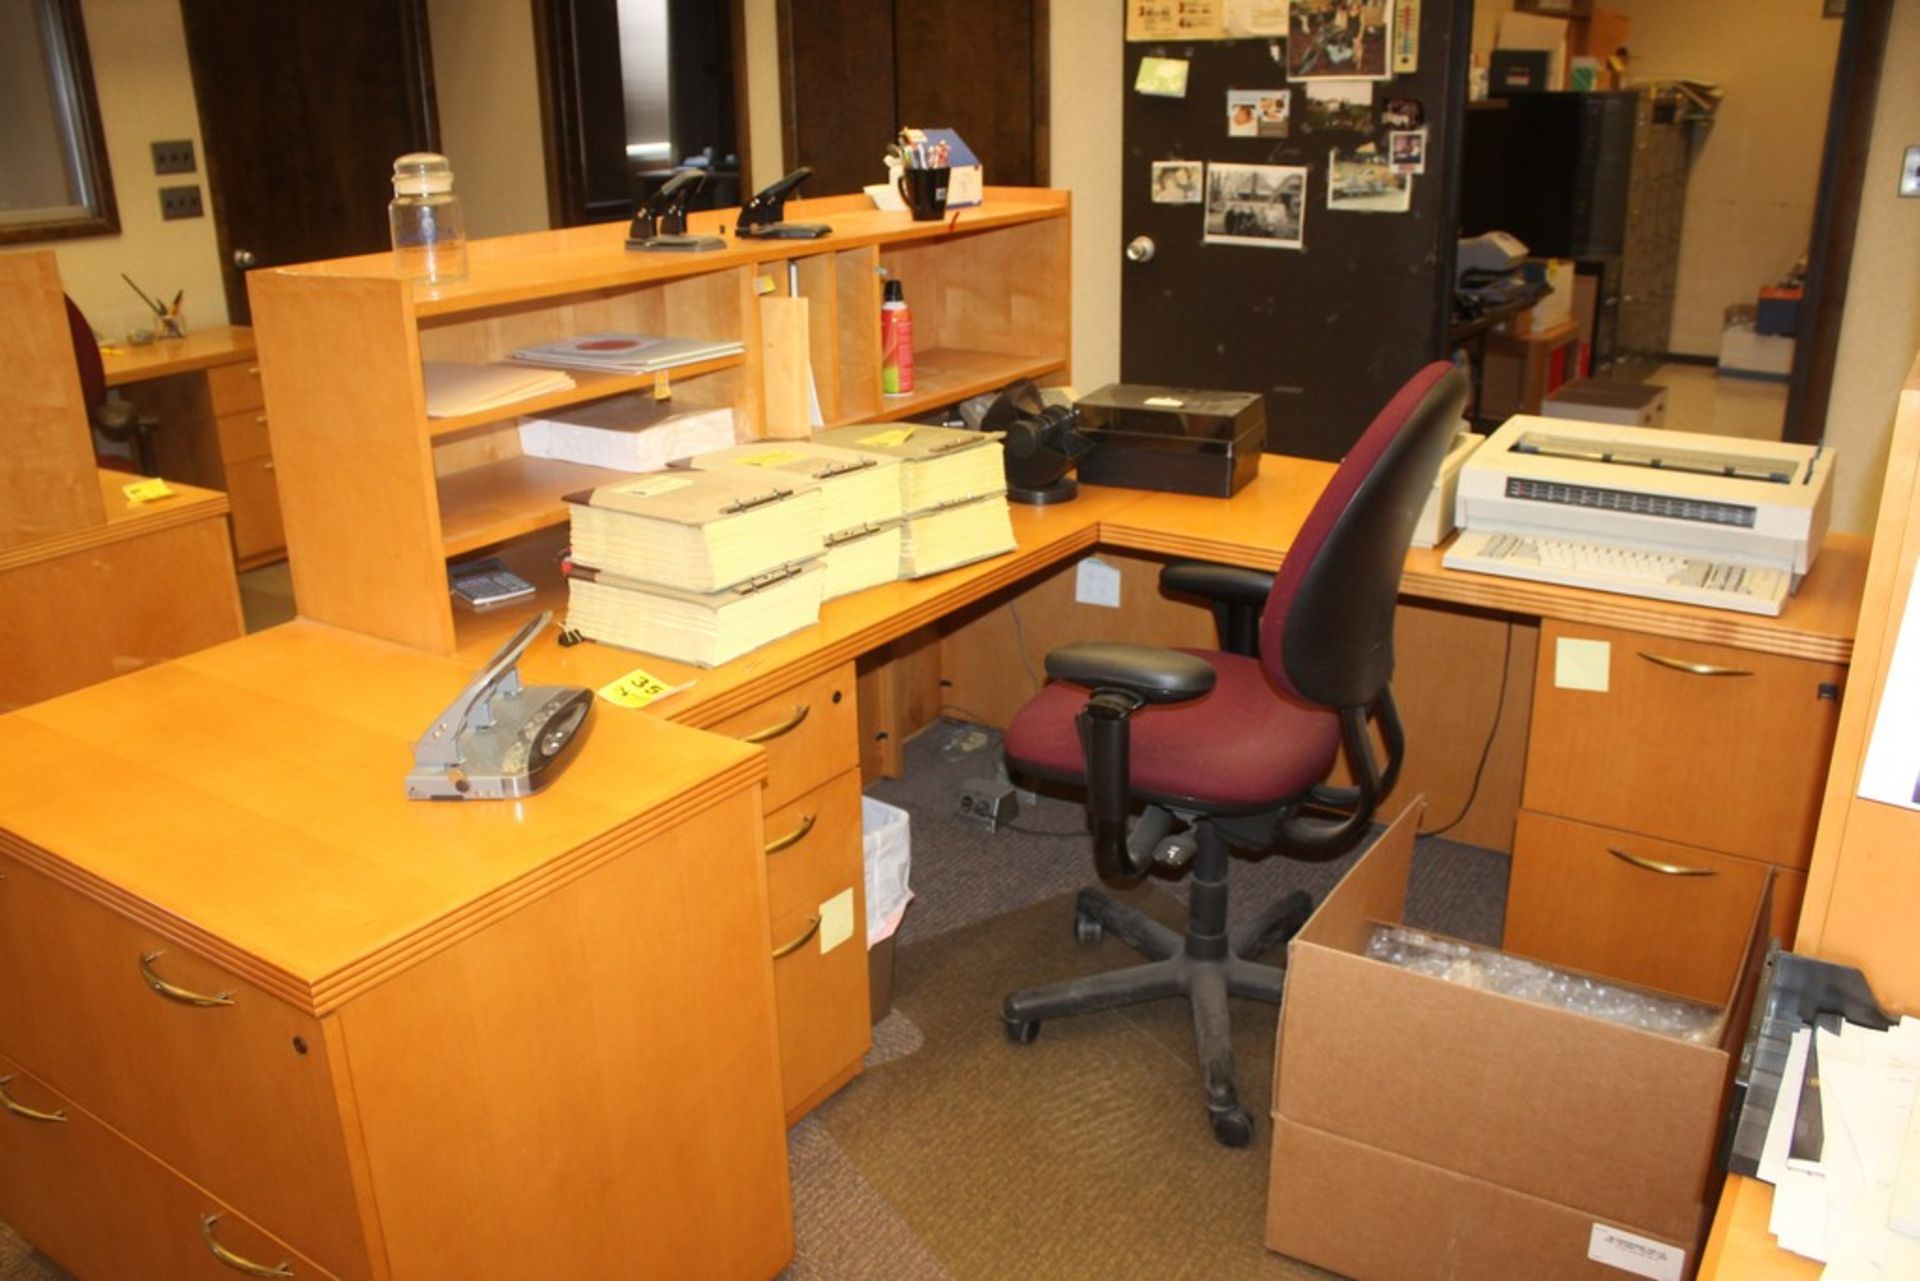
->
[770, 891, 874, 1125]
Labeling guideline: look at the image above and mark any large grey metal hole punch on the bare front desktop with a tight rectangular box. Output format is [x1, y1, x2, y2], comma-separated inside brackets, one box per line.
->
[407, 609, 593, 801]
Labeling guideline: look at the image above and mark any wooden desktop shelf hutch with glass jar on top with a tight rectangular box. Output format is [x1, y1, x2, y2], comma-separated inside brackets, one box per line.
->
[248, 188, 1071, 653]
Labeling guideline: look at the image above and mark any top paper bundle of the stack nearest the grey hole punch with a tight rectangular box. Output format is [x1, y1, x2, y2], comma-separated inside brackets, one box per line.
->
[566, 471, 826, 592]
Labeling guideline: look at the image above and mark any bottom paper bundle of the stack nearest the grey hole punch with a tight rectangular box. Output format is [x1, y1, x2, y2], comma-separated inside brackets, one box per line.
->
[566, 561, 826, 666]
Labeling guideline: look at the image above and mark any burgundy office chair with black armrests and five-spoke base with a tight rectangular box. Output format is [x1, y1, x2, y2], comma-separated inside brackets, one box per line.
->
[1002, 363, 1467, 1147]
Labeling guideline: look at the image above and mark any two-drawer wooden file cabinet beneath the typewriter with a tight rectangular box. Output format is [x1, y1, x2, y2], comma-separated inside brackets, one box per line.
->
[1505, 618, 1845, 1001]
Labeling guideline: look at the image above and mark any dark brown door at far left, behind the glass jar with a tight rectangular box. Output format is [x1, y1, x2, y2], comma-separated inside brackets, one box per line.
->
[180, 0, 435, 325]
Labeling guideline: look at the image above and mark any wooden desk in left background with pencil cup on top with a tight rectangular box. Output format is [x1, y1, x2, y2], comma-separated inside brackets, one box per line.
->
[102, 325, 286, 568]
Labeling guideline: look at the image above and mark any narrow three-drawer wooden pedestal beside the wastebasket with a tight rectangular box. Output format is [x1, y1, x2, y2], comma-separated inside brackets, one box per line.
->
[712, 663, 872, 1125]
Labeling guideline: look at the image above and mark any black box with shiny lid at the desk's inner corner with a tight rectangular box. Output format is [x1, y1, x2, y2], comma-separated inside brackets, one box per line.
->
[1073, 382, 1267, 497]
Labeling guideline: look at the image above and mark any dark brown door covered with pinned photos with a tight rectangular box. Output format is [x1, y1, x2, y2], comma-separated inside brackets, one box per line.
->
[1121, 10, 1473, 459]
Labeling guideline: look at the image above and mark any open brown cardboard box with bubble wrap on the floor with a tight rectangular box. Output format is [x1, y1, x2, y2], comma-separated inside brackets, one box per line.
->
[1267, 803, 1770, 1281]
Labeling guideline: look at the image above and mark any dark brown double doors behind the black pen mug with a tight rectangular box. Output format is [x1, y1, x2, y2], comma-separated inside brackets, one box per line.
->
[780, 0, 1046, 196]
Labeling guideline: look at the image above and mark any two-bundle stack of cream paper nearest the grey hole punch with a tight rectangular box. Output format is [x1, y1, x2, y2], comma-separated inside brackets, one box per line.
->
[566, 471, 826, 666]
